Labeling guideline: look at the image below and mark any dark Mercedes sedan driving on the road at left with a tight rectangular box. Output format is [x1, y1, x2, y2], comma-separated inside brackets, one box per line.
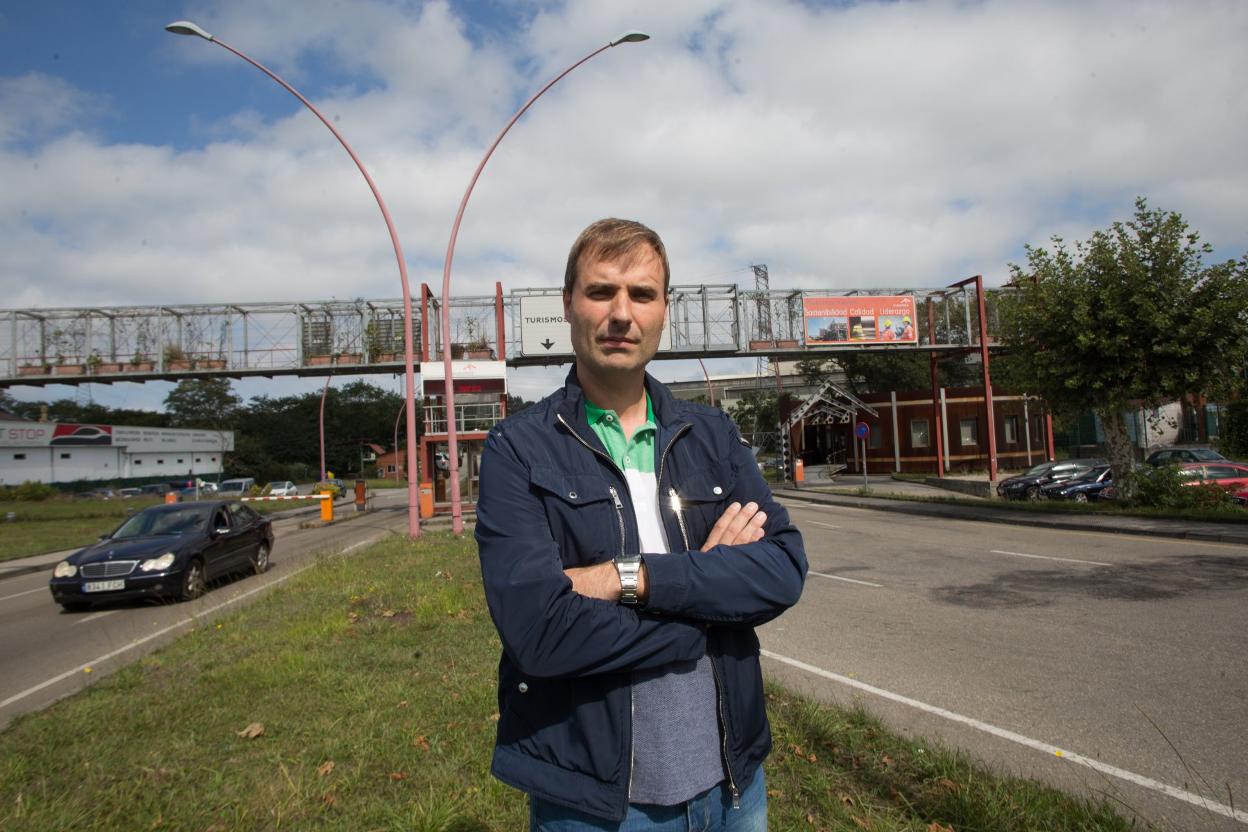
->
[49, 500, 273, 610]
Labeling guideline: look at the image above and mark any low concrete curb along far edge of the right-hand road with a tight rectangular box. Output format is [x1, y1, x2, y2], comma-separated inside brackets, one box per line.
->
[774, 489, 1248, 545]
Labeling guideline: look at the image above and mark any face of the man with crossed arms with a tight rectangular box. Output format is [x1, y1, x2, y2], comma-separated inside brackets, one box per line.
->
[563, 246, 668, 380]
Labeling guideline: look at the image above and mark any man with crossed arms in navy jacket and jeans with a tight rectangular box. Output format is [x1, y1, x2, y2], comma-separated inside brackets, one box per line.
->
[477, 220, 806, 832]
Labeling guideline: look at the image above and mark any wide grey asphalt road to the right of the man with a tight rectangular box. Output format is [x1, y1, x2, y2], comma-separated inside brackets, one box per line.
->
[759, 501, 1248, 832]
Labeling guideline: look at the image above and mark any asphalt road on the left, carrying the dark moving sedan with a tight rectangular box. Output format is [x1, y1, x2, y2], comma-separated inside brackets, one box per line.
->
[0, 489, 407, 727]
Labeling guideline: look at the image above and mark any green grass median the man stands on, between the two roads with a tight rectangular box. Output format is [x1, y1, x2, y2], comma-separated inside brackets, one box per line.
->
[0, 534, 1129, 832]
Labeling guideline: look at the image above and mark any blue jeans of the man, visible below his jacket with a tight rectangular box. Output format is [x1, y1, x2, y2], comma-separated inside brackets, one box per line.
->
[529, 767, 768, 832]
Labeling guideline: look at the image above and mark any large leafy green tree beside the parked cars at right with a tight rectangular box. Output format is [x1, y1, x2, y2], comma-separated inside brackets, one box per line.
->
[1000, 198, 1248, 499]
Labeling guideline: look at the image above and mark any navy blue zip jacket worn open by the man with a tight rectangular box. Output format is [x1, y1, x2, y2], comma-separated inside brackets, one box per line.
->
[477, 367, 806, 820]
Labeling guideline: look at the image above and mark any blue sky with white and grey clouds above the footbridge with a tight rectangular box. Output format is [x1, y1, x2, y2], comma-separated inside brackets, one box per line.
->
[0, 0, 1248, 408]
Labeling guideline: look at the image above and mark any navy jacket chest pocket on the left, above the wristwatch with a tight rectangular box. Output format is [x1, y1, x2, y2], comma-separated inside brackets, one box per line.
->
[529, 467, 625, 566]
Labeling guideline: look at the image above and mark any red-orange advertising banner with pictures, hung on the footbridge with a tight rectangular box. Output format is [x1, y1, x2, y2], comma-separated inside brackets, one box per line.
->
[801, 294, 919, 347]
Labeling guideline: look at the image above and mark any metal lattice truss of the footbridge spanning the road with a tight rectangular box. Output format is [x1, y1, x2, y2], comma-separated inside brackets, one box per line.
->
[0, 281, 996, 387]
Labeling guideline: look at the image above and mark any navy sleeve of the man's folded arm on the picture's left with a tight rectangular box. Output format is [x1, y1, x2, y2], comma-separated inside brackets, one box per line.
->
[477, 428, 706, 677]
